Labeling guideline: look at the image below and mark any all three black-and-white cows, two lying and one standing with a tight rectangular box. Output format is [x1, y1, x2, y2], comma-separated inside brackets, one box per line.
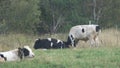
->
[0, 25, 101, 62]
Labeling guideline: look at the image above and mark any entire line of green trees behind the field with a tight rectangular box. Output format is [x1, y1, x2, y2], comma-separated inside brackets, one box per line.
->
[0, 0, 120, 34]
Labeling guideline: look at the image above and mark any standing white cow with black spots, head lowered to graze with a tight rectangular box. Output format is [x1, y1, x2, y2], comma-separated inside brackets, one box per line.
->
[67, 25, 101, 47]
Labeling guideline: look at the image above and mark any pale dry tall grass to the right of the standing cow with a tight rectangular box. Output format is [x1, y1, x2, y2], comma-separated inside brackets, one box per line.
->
[100, 29, 120, 46]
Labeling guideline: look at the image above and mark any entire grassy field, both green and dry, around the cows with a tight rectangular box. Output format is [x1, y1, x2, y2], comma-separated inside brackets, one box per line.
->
[0, 29, 120, 68]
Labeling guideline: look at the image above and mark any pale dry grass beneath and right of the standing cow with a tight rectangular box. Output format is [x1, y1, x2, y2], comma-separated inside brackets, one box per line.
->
[74, 28, 120, 48]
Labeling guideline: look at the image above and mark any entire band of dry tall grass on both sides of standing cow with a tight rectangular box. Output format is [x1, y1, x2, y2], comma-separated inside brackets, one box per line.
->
[0, 29, 120, 51]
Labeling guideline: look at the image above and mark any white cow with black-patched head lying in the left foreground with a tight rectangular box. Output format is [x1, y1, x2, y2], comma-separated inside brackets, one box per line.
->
[0, 46, 34, 61]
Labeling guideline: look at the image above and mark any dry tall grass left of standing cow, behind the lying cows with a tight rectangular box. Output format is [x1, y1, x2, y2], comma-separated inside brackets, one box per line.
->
[0, 34, 67, 51]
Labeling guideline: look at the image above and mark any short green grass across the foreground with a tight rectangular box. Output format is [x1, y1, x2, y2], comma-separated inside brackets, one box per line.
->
[0, 47, 120, 68]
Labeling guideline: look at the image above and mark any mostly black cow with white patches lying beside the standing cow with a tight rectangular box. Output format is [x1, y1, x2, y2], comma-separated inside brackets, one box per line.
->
[33, 38, 69, 49]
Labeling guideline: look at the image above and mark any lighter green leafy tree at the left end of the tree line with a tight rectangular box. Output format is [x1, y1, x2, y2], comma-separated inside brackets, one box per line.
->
[0, 0, 40, 33]
